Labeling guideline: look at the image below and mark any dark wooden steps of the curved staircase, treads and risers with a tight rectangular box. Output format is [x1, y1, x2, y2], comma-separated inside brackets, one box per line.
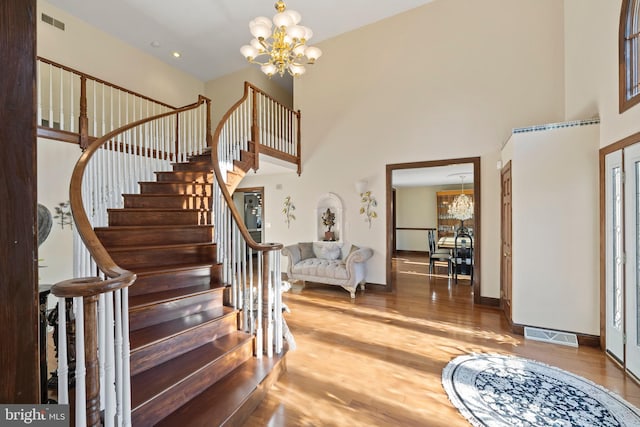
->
[95, 151, 284, 426]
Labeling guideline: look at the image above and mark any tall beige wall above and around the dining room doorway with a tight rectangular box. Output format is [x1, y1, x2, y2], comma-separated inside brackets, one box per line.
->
[278, 0, 564, 297]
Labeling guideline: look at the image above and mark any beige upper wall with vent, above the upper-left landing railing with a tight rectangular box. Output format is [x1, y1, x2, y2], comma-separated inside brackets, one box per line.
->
[36, 0, 204, 106]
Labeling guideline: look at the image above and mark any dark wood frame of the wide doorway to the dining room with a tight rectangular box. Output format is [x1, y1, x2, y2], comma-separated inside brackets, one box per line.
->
[386, 157, 481, 304]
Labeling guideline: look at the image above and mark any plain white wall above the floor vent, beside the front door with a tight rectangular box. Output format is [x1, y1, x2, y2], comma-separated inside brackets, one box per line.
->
[509, 125, 600, 335]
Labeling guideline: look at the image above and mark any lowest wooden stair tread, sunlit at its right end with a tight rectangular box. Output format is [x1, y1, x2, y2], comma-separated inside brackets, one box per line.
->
[156, 352, 286, 427]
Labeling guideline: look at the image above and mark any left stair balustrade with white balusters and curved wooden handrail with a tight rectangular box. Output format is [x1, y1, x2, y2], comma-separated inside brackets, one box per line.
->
[51, 96, 211, 426]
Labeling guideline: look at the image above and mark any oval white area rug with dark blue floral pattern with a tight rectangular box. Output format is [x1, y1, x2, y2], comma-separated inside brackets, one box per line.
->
[442, 354, 640, 427]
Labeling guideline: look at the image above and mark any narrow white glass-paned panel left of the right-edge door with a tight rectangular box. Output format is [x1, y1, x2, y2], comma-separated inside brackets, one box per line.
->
[605, 151, 624, 363]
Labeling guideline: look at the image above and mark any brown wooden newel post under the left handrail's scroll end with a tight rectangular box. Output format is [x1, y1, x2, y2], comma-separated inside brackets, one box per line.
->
[84, 295, 101, 426]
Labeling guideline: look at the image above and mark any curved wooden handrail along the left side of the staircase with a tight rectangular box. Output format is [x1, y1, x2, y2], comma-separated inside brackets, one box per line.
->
[70, 95, 209, 286]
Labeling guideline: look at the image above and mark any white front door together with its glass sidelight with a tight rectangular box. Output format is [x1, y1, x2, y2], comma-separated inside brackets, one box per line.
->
[605, 144, 640, 377]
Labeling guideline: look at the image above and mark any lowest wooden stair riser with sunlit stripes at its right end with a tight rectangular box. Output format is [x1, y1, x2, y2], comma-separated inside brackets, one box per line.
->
[108, 209, 211, 226]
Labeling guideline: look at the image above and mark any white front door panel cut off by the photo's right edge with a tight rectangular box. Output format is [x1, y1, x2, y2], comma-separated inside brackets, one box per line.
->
[624, 144, 640, 376]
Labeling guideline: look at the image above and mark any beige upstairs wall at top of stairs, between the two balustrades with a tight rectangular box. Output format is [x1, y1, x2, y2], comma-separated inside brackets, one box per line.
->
[205, 65, 293, 130]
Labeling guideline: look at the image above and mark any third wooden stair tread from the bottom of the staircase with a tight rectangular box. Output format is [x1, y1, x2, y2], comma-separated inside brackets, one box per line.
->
[129, 306, 235, 353]
